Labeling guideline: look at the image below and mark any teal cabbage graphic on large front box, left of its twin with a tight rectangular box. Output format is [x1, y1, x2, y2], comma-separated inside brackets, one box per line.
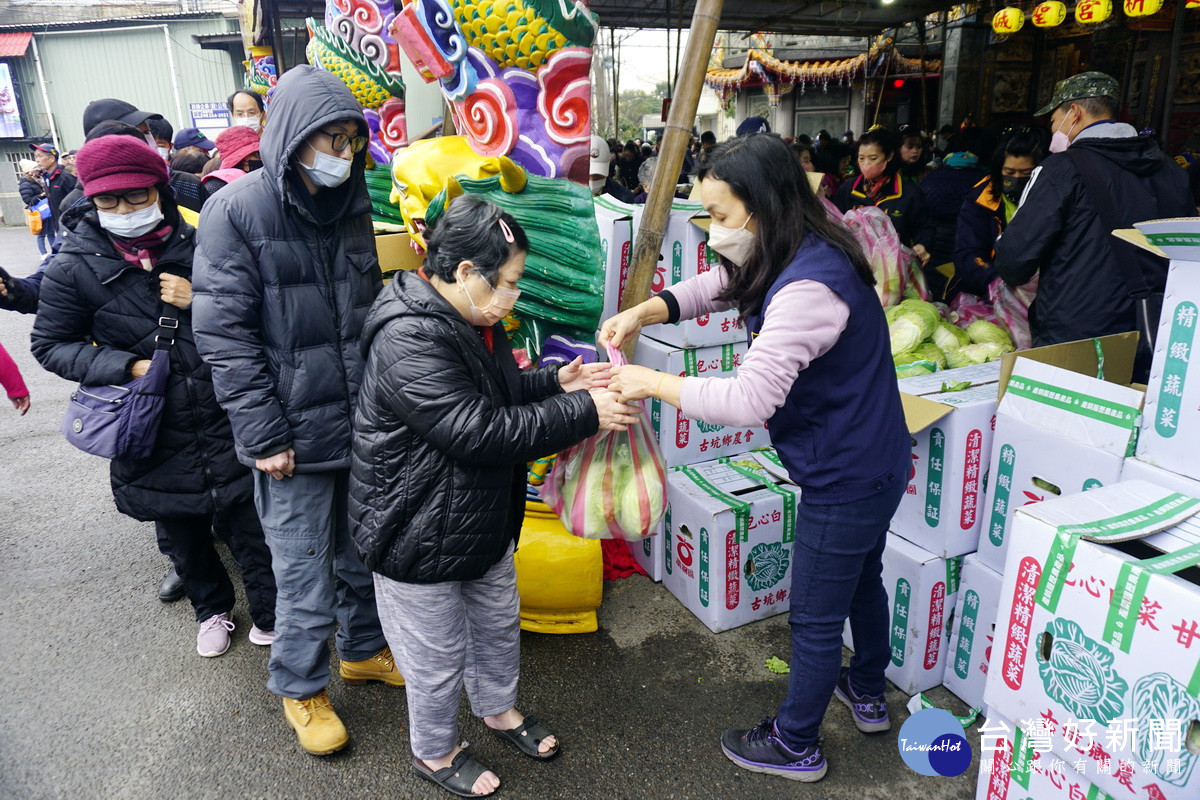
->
[1036, 619, 1128, 724]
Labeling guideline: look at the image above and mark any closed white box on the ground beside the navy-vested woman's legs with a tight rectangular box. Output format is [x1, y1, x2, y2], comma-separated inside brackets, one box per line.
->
[662, 458, 799, 633]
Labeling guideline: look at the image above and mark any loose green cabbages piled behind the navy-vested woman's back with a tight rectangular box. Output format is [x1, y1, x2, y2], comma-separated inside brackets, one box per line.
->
[884, 300, 1014, 378]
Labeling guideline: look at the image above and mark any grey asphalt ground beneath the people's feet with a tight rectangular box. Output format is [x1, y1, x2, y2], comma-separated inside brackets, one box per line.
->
[0, 228, 978, 800]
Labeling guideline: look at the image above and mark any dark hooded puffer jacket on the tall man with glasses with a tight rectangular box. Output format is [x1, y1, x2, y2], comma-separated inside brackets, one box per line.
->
[193, 66, 382, 473]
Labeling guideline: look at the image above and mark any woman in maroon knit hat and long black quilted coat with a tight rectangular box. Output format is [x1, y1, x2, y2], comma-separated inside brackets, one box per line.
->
[32, 136, 275, 657]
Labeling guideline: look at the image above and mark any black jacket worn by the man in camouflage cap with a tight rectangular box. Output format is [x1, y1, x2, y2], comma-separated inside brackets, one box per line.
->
[992, 122, 1195, 347]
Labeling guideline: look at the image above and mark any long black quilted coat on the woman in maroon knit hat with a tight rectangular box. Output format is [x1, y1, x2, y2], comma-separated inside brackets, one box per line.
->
[32, 211, 252, 521]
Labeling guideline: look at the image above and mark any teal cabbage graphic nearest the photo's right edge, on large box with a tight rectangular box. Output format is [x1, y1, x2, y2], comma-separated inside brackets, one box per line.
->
[1130, 672, 1200, 786]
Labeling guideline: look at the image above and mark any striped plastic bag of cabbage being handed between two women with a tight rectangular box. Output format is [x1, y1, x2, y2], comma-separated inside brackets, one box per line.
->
[541, 350, 667, 540]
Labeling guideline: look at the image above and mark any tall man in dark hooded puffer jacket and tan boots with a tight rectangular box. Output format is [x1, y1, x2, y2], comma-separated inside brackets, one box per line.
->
[192, 65, 404, 756]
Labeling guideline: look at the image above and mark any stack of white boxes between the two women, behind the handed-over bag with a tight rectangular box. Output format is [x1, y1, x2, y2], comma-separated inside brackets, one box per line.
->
[595, 196, 799, 631]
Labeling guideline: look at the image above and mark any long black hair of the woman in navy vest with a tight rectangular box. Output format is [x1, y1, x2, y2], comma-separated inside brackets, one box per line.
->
[696, 133, 875, 317]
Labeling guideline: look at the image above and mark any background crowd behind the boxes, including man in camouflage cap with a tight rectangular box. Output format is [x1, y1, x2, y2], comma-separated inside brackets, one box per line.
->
[592, 72, 1200, 362]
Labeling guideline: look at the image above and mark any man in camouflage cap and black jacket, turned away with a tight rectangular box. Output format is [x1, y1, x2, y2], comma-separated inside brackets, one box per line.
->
[992, 72, 1195, 379]
